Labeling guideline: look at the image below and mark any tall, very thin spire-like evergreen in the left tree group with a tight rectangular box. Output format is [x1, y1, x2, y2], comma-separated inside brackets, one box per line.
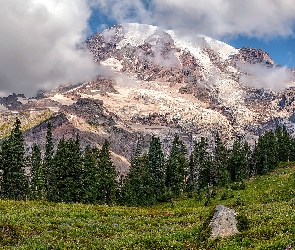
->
[43, 122, 54, 200]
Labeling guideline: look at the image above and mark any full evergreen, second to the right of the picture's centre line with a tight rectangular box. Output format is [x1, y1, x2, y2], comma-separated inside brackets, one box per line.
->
[166, 135, 187, 197]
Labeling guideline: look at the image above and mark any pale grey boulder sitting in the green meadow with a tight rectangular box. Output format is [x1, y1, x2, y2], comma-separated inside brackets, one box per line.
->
[209, 205, 239, 238]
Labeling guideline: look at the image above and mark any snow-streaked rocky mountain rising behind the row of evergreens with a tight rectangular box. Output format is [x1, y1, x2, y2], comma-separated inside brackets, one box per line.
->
[0, 24, 295, 173]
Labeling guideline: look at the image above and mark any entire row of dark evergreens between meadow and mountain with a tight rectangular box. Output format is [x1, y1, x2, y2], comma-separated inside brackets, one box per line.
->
[0, 119, 295, 206]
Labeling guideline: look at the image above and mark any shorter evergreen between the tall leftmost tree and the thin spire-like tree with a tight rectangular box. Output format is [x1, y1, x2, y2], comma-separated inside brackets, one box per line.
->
[29, 144, 46, 200]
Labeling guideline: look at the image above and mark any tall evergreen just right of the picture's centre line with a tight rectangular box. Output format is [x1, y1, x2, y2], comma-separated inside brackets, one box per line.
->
[147, 136, 167, 201]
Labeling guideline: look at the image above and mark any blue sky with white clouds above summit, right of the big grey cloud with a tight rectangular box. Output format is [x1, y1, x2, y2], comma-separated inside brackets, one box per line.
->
[88, 0, 295, 68]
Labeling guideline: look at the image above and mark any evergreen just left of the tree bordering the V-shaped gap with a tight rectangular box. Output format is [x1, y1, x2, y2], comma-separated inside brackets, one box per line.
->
[81, 145, 100, 203]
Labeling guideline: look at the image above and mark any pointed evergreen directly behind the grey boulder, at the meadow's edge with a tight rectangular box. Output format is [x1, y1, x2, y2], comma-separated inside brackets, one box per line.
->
[211, 132, 230, 186]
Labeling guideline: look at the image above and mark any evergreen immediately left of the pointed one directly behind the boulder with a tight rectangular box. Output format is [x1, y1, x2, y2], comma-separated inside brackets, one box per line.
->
[186, 137, 212, 193]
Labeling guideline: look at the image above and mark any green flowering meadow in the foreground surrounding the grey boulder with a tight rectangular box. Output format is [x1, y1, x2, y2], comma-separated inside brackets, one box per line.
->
[0, 164, 295, 250]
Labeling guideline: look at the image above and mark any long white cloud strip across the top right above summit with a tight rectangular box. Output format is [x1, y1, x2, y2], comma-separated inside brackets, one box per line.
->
[92, 0, 295, 37]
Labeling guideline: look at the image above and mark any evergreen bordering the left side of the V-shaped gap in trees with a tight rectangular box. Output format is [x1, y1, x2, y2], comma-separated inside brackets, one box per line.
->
[98, 140, 118, 205]
